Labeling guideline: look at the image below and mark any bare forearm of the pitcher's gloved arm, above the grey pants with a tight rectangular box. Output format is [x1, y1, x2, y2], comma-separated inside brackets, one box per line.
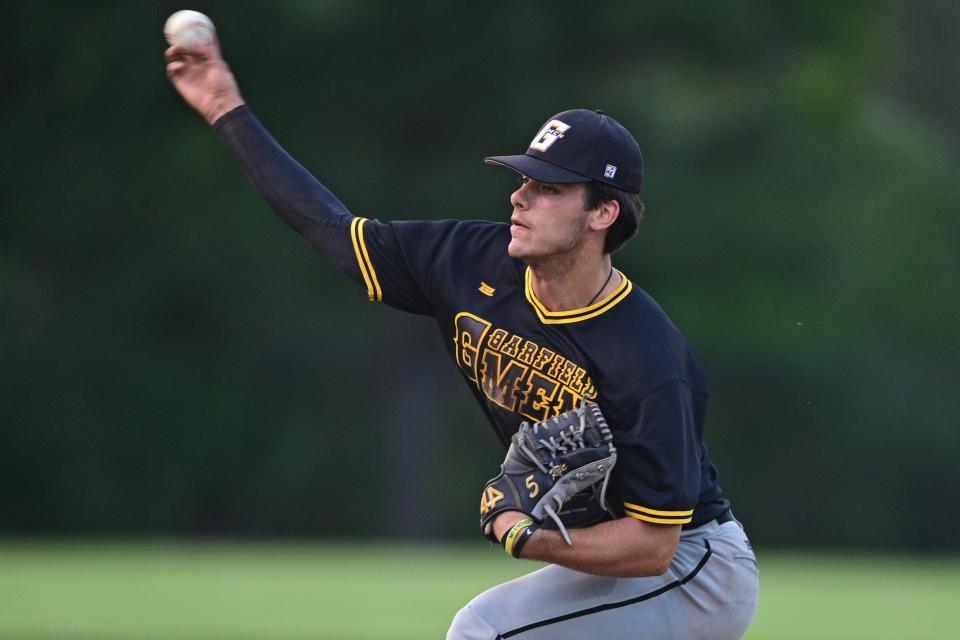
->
[521, 518, 679, 577]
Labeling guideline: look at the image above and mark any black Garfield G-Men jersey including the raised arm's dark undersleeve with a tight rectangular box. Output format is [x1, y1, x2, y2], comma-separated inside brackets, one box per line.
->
[215, 106, 730, 528]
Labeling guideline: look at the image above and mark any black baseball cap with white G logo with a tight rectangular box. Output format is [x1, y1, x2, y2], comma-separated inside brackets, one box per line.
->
[483, 109, 643, 192]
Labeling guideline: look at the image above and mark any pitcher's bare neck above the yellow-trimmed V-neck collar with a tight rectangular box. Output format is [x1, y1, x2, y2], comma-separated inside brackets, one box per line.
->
[530, 255, 620, 311]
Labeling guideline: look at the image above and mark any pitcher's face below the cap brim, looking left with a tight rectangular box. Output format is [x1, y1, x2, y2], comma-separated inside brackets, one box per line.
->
[507, 177, 589, 262]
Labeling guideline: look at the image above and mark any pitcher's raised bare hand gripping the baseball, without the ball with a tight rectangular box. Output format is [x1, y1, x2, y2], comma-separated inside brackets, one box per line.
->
[164, 38, 244, 124]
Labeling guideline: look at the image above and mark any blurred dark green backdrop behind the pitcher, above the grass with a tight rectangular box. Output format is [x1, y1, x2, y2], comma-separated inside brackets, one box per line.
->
[0, 0, 960, 637]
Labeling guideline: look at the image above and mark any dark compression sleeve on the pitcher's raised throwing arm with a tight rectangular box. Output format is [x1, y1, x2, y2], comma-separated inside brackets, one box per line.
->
[213, 105, 359, 280]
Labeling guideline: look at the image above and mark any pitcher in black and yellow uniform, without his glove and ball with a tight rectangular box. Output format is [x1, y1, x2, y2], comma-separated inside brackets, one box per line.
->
[166, 33, 759, 640]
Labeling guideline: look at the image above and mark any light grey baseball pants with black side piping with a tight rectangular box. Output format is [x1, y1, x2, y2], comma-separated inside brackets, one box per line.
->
[447, 520, 760, 640]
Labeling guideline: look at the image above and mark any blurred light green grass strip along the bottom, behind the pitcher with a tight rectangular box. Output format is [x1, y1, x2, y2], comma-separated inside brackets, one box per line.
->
[0, 542, 960, 640]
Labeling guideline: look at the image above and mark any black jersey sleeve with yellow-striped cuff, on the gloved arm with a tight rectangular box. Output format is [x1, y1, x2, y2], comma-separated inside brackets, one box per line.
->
[614, 380, 701, 525]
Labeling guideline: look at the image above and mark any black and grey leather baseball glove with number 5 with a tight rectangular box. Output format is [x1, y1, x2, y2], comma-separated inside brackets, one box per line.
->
[480, 400, 617, 544]
